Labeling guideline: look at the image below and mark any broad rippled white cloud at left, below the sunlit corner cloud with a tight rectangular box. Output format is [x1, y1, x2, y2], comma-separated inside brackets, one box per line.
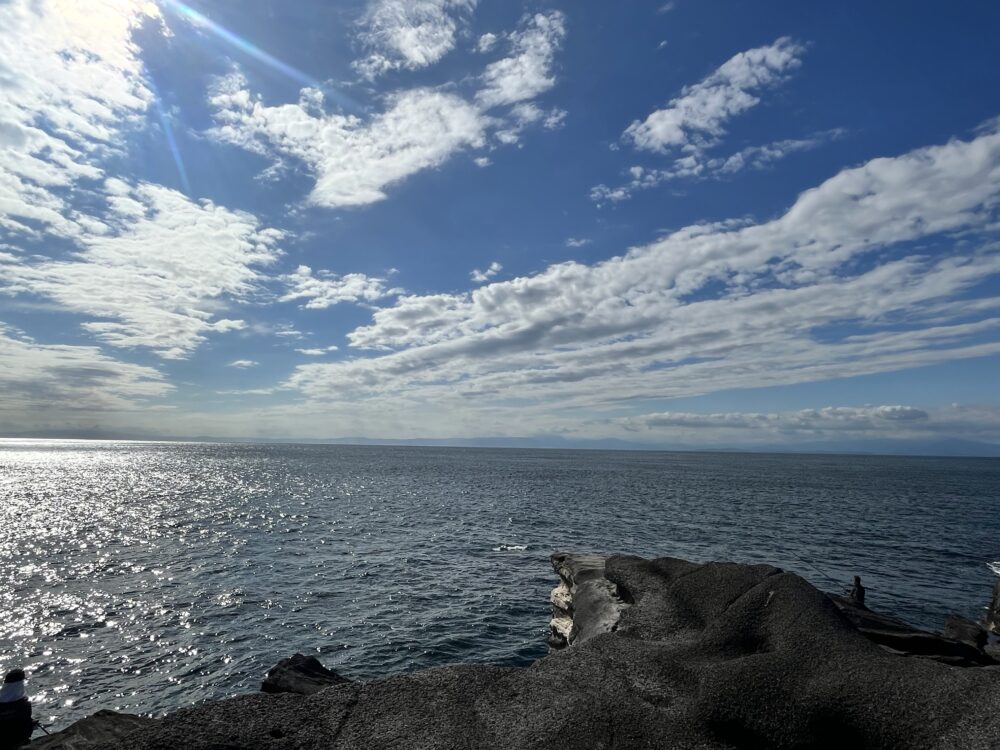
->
[0, 180, 281, 359]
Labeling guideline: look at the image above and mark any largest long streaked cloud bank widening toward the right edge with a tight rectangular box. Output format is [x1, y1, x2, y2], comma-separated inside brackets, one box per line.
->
[285, 123, 1000, 418]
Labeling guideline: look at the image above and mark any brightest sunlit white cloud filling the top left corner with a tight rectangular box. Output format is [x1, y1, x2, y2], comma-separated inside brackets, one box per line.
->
[0, 0, 162, 239]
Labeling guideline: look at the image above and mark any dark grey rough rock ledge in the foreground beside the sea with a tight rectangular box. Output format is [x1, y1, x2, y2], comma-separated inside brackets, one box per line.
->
[31, 555, 1000, 750]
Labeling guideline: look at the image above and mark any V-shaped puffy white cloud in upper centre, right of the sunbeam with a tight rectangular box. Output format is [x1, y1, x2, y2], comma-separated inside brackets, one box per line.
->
[210, 12, 565, 208]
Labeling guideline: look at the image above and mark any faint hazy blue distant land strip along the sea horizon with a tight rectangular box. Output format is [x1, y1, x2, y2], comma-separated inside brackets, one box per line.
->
[3, 428, 1000, 458]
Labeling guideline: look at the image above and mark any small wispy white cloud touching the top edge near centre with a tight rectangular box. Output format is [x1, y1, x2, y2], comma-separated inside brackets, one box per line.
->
[354, 0, 477, 79]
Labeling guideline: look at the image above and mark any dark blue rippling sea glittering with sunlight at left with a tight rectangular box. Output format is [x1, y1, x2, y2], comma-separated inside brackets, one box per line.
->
[0, 441, 1000, 726]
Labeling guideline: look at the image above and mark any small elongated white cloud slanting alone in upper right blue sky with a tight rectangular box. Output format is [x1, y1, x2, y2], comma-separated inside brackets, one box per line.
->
[623, 37, 804, 153]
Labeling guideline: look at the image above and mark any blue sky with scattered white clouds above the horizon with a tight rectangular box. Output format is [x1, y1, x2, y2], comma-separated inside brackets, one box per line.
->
[0, 0, 1000, 448]
